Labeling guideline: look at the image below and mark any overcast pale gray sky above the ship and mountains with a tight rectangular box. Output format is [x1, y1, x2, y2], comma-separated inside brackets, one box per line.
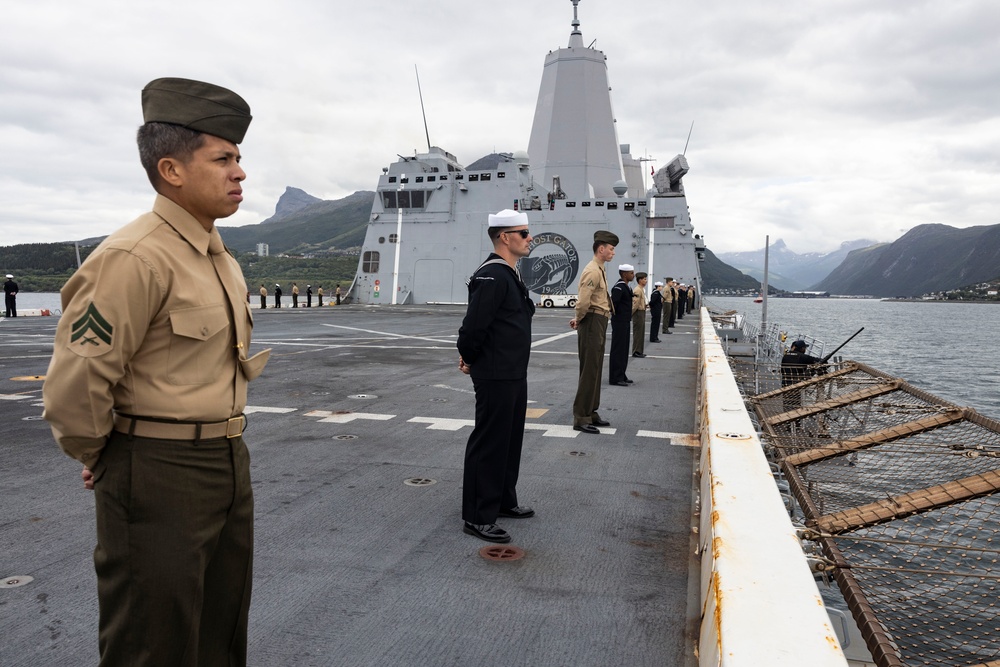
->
[0, 0, 1000, 252]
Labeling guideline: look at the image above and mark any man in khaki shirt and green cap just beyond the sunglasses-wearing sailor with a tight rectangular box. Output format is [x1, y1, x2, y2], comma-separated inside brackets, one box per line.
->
[569, 230, 618, 433]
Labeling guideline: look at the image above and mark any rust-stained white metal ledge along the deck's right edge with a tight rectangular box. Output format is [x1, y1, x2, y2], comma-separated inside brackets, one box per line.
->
[698, 308, 847, 667]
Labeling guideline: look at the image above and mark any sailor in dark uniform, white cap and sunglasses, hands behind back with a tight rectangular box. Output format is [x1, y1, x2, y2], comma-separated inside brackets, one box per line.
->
[458, 209, 535, 542]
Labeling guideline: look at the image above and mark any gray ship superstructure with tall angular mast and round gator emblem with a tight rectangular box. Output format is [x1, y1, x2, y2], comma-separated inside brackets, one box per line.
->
[350, 0, 704, 304]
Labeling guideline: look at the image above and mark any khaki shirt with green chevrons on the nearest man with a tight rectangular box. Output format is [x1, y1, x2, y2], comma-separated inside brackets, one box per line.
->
[42, 196, 270, 466]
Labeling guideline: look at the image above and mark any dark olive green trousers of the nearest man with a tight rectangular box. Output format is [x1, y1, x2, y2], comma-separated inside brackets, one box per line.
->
[93, 432, 253, 667]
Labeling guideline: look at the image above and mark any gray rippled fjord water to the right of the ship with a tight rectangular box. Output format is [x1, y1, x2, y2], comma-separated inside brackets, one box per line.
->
[706, 296, 1000, 419]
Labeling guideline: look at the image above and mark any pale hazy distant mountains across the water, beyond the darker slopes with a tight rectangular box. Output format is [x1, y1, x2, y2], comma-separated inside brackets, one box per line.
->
[719, 239, 875, 291]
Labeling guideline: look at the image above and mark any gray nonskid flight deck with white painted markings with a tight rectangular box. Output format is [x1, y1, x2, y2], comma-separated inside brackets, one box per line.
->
[0, 306, 698, 667]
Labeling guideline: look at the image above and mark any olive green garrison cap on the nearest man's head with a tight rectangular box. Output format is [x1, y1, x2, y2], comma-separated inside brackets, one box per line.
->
[142, 78, 253, 144]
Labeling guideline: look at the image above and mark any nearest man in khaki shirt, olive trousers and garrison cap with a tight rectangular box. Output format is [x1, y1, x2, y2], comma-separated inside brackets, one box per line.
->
[43, 78, 270, 667]
